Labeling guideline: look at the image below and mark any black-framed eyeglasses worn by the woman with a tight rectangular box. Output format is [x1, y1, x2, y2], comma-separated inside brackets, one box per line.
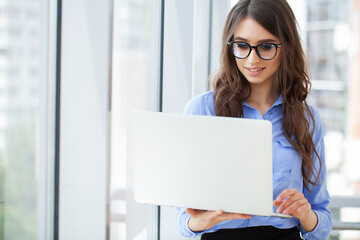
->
[228, 41, 282, 60]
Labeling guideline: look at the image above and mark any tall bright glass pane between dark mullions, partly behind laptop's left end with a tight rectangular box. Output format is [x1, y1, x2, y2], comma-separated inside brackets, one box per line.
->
[110, 0, 161, 240]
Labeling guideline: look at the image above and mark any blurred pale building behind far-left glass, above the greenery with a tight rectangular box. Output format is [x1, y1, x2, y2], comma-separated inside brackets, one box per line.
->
[0, 0, 40, 151]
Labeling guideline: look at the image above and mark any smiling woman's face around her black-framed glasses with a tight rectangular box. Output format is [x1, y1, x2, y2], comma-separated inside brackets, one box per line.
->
[234, 17, 281, 85]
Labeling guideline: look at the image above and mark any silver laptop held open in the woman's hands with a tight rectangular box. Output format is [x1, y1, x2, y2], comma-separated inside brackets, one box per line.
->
[129, 111, 291, 217]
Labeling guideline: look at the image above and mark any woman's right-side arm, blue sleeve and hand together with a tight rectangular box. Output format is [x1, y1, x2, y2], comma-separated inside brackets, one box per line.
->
[274, 111, 332, 240]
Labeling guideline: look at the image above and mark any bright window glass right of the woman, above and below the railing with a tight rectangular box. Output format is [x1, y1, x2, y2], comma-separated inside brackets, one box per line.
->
[307, 0, 360, 240]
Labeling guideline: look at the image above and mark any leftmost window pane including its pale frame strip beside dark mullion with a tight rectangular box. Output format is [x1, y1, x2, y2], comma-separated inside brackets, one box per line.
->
[0, 0, 55, 240]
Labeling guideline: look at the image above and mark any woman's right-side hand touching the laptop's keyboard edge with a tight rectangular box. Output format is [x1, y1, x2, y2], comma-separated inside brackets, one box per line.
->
[274, 189, 318, 232]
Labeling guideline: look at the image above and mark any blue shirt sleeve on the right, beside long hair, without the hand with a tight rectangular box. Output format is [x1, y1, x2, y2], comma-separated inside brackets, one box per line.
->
[300, 108, 332, 240]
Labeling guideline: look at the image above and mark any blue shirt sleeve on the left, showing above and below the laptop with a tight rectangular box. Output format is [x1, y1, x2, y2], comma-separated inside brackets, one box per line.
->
[176, 95, 204, 238]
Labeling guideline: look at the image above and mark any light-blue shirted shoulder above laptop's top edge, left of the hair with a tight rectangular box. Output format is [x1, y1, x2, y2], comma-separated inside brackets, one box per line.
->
[184, 91, 215, 115]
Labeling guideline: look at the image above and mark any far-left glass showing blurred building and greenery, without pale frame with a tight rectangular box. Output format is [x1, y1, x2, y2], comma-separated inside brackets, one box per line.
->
[0, 0, 41, 239]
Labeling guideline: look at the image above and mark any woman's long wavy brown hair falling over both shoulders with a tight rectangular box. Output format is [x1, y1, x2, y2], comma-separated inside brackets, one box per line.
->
[213, 0, 321, 191]
